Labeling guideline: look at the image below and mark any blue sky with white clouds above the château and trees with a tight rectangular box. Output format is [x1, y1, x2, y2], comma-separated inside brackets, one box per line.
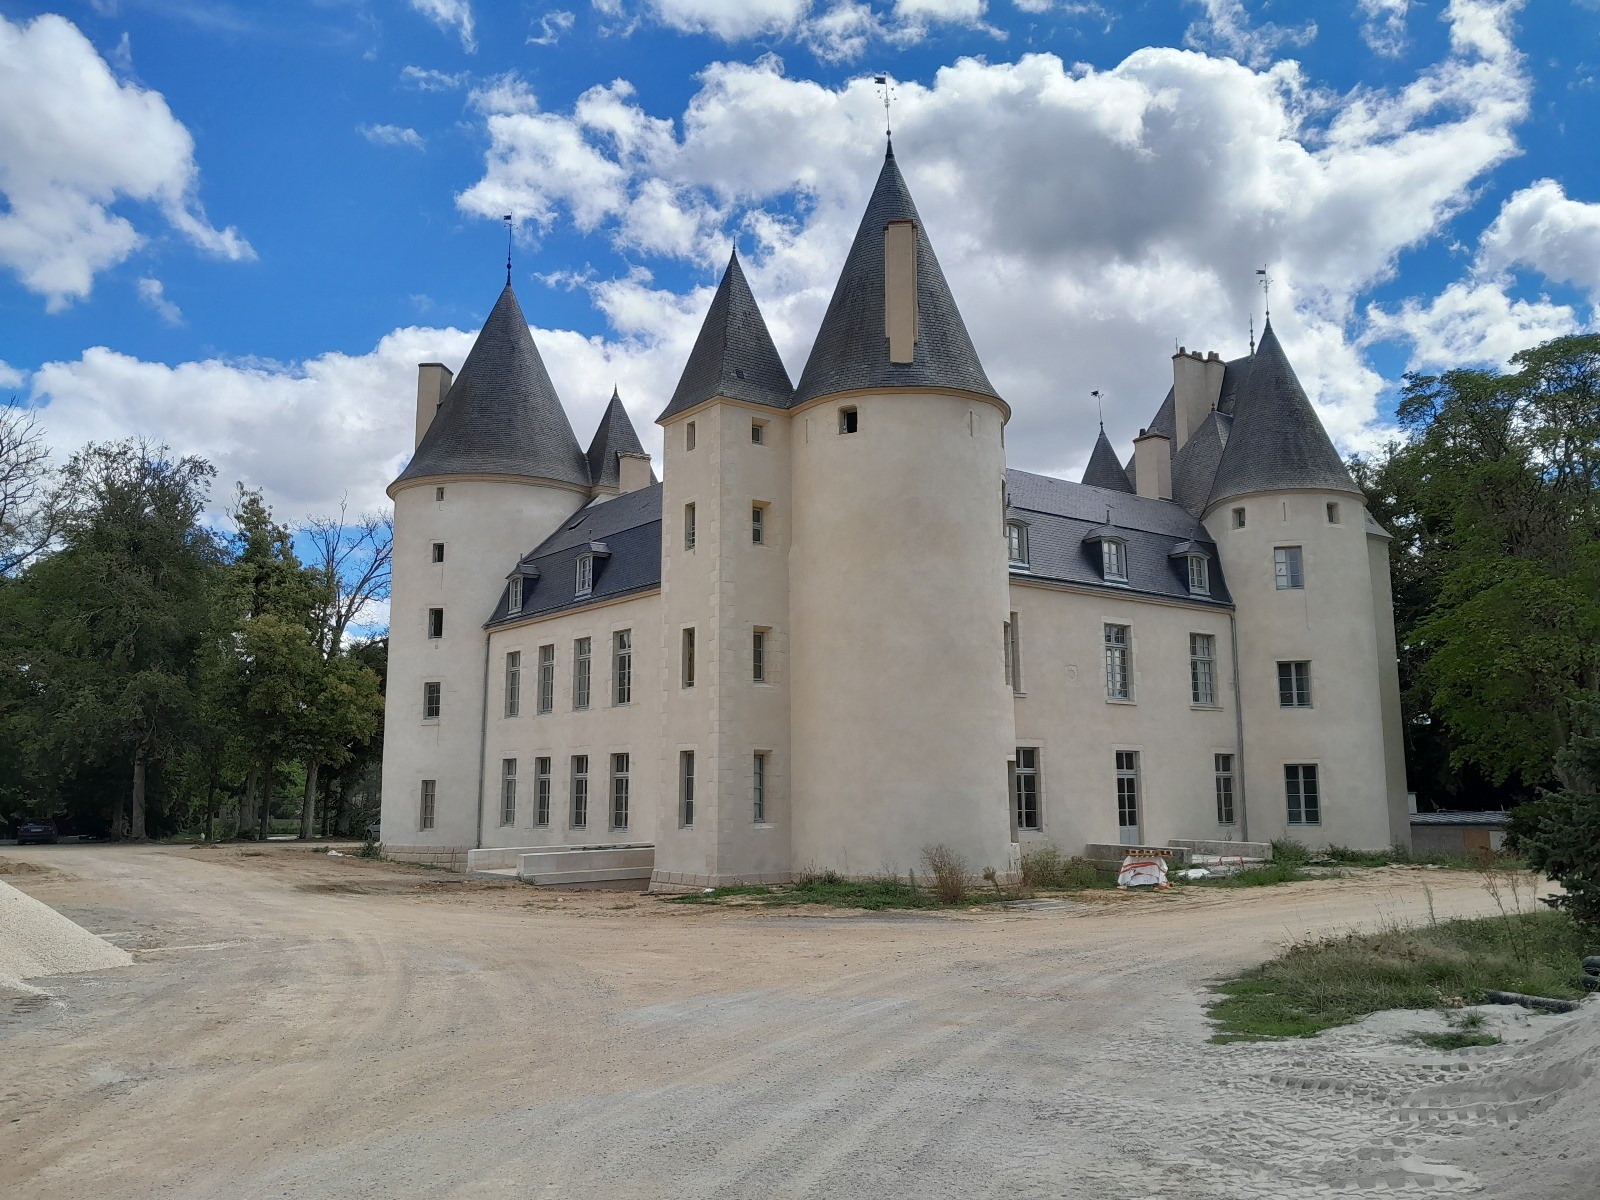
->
[0, 0, 1600, 518]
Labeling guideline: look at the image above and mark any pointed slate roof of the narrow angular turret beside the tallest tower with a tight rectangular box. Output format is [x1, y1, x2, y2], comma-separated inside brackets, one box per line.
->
[656, 250, 795, 421]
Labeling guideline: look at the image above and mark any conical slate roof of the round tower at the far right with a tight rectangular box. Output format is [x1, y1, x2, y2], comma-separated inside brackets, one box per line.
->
[1206, 320, 1362, 507]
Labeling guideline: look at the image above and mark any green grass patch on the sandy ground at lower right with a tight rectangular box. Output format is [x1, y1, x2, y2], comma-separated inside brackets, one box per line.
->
[1210, 912, 1586, 1042]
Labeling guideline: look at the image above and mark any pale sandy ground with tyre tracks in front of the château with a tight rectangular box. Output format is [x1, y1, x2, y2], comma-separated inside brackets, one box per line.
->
[0, 845, 1600, 1200]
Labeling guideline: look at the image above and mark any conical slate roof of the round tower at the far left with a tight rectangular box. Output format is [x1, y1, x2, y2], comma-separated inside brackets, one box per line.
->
[395, 283, 589, 488]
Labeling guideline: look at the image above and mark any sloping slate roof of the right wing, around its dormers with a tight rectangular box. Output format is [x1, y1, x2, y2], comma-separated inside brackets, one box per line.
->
[1005, 470, 1232, 608]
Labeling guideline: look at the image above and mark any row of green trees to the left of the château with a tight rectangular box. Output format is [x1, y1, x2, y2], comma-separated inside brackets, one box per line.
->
[0, 408, 392, 840]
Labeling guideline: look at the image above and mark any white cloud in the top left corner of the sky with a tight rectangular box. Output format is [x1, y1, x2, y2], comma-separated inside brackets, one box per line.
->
[0, 16, 254, 312]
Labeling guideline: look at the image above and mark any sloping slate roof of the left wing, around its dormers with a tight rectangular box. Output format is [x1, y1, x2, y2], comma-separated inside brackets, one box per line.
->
[485, 483, 661, 626]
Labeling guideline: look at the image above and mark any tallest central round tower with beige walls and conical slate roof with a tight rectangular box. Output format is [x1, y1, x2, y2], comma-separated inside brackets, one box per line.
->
[789, 147, 1016, 875]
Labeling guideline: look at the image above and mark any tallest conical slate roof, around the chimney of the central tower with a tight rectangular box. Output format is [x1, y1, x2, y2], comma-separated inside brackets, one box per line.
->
[794, 146, 998, 405]
